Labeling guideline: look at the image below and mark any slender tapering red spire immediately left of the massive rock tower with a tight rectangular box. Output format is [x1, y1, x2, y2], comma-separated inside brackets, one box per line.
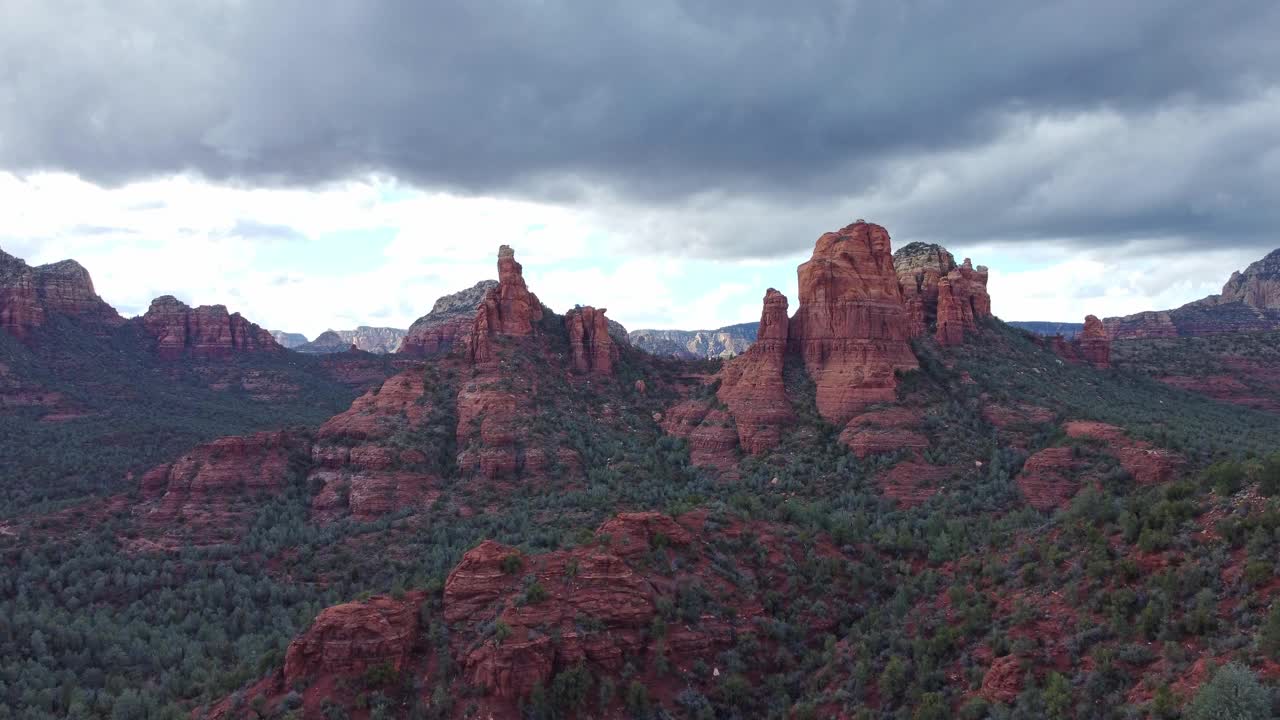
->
[708, 287, 794, 455]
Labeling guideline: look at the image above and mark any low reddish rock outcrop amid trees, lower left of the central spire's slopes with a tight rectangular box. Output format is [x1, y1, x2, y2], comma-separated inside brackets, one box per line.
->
[138, 432, 308, 542]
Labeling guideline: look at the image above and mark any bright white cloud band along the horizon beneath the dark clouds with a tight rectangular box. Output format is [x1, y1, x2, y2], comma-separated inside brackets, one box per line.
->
[0, 169, 1256, 337]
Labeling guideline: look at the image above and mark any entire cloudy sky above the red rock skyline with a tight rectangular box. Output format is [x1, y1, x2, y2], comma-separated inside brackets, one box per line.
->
[0, 0, 1280, 337]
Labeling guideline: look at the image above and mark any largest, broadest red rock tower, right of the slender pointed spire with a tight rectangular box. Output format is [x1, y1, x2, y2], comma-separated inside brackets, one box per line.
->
[788, 222, 919, 424]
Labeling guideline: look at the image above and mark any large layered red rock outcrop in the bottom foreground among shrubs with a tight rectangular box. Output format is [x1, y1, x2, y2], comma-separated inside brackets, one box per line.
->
[211, 512, 842, 720]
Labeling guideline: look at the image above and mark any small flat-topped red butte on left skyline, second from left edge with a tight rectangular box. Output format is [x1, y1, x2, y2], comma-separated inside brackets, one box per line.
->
[142, 295, 284, 359]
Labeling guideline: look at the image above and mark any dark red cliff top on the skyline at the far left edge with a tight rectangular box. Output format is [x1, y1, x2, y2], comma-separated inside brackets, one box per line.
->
[0, 250, 124, 338]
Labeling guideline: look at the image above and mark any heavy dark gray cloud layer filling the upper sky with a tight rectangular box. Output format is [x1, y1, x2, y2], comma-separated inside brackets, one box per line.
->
[0, 0, 1280, 256]
